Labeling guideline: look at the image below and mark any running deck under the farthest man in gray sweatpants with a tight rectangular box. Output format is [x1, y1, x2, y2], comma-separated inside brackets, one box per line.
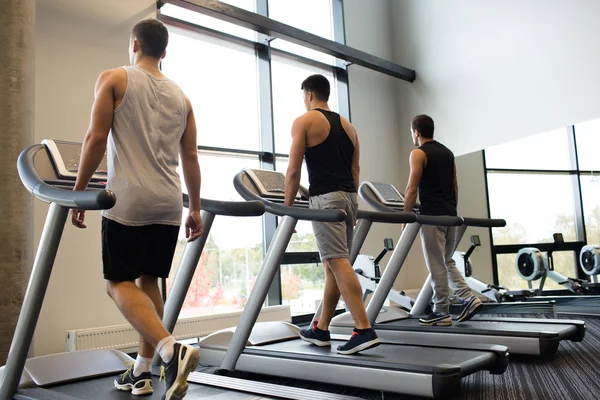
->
[382, 317, 578, 339]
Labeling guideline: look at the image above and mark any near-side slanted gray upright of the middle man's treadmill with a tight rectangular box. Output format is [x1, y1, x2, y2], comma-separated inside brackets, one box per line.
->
[221, 215, 298, 370]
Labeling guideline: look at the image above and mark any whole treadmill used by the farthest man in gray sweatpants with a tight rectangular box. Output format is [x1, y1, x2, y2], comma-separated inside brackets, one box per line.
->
[330, 182, 585, 355]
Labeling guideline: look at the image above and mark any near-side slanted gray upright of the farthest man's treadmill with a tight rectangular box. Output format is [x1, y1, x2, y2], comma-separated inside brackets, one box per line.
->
[367, 222, 421, 324]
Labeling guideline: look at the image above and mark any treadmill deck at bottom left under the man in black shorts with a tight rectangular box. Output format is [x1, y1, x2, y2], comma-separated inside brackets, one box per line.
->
[14, 376, 274, 400]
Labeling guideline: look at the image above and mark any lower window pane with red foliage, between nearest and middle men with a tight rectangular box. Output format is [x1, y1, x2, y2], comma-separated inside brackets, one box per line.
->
[167, 152, 263, 316]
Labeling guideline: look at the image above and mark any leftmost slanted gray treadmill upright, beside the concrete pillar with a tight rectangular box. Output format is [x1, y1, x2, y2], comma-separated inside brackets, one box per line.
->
[0, 203, 69, 399]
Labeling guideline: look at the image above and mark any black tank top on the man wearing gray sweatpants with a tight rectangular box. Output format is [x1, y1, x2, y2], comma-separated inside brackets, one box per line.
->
[419, 140, 456, 216]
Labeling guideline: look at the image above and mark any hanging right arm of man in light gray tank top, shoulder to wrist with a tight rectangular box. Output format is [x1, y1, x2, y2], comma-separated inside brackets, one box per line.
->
[179, 97, 201, 212]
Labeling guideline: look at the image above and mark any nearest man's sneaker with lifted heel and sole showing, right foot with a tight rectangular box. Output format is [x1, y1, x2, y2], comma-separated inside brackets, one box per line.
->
[160, 343, 200, 400]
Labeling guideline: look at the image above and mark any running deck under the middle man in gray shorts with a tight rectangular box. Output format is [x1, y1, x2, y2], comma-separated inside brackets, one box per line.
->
[244, 339, 498, 376]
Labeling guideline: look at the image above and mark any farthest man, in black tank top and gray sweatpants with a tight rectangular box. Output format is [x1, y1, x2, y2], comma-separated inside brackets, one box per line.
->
[404, 115, 482, 326]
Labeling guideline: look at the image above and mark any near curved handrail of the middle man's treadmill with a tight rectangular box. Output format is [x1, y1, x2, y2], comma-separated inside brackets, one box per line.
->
[233, 171, 346, 222]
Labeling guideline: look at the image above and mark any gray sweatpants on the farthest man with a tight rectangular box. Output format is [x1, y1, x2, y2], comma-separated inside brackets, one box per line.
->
[421, 225, 472, 313]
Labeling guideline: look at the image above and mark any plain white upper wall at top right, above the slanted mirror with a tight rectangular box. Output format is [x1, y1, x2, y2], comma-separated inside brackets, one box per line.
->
[392, 0, 600, 155]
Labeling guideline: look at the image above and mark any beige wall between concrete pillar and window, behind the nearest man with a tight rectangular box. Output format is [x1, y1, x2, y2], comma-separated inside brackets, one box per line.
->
[33, 0, 156, 355]
